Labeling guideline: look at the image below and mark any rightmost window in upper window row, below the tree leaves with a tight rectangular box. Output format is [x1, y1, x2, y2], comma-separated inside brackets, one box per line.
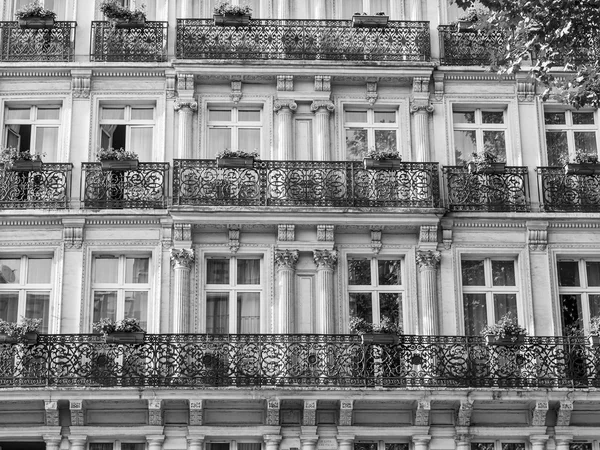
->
[544, 111, 598, 166]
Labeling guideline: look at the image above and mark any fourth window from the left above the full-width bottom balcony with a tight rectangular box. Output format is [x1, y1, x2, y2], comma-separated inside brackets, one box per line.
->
[348, 257, 403, 326]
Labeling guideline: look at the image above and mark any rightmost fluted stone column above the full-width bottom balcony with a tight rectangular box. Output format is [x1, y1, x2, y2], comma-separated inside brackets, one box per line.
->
[417, 250, 441, 336]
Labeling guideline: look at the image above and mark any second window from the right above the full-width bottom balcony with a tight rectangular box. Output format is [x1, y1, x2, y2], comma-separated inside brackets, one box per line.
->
[461, 258, 518, 336]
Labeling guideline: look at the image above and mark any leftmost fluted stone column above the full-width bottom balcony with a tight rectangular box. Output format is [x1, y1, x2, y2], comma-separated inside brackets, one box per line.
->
[171, 248, 194, 333]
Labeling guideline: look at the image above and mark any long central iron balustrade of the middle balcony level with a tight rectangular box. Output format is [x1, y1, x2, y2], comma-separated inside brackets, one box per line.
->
[173, 159, 439, 208]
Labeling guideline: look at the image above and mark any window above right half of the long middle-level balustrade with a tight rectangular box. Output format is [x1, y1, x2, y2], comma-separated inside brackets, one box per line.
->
[344, 108, 398, 160]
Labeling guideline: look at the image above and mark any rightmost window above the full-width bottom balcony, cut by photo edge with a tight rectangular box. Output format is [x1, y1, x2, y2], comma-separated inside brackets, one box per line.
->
[557, 259, 600, 335]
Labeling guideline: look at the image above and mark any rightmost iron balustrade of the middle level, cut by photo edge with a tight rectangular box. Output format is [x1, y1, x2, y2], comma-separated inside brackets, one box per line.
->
[537, 167, 600, 211]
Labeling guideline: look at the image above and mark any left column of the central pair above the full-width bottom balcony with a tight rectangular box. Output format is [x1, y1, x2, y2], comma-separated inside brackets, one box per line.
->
[275, 250, 298, 334]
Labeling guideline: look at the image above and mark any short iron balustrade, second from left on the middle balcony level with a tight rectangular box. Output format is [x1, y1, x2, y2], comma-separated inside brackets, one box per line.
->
[81, 162, 170, 209]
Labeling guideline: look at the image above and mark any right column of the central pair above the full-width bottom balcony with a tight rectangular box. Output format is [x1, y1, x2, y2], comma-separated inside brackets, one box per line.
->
[313, 250, 337, 334]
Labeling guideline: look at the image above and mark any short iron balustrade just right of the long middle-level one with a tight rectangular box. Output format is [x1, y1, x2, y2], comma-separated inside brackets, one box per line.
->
[443, 166, 529, 212]
